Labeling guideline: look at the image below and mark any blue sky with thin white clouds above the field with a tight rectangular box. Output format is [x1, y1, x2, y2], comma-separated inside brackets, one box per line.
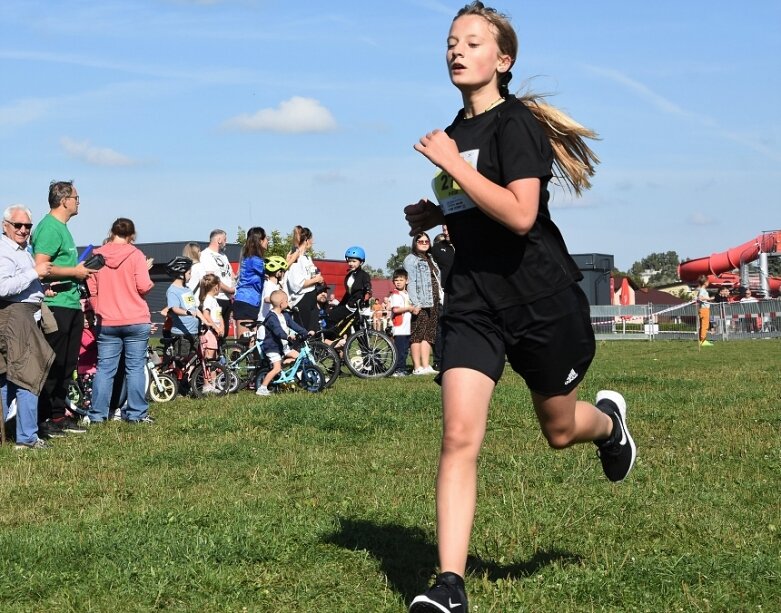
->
[0, 0, 781, 269]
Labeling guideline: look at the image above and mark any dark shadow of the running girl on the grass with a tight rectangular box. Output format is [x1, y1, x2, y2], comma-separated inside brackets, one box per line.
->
[324, 518, 580, 602]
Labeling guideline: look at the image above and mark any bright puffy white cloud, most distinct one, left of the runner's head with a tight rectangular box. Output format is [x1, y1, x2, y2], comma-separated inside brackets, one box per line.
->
[224, 96, 336, 134]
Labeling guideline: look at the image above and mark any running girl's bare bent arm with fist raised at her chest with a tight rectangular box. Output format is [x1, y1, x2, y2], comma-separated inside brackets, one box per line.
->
[415, 130, 540, 235]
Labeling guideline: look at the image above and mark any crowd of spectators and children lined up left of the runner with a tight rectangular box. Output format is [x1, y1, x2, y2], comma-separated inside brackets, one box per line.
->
[0, 181, 454, 450]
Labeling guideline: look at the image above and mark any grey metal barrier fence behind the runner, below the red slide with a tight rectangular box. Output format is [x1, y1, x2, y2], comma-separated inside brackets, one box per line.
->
[591, 299, 781, 341]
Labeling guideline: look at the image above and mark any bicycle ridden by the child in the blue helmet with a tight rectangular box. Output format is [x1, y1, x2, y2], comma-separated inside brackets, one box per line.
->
[323, 300, 396, 379]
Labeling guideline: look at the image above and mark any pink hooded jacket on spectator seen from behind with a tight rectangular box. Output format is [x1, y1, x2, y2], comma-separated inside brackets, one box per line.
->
[87, 243, 154, 326]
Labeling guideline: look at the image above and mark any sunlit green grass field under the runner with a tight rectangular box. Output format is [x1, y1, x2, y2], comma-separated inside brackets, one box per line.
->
[0, 341, 781, 613]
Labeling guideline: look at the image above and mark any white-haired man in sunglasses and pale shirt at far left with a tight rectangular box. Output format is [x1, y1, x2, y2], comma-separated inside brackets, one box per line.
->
[0, 204, 54, 450]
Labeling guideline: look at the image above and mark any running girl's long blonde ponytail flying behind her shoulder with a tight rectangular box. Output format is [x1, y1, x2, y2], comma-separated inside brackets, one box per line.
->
[518, 93, 599, 196]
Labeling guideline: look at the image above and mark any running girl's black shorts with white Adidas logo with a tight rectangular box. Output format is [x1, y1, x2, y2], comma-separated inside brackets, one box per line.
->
[440, 285, 596, 396]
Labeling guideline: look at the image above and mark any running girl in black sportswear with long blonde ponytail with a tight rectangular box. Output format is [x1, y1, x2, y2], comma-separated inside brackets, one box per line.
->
[405, 2, 636, 613]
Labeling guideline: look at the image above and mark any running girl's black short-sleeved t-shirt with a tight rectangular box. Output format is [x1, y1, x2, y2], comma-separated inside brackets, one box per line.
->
[433, 97, 582, 309]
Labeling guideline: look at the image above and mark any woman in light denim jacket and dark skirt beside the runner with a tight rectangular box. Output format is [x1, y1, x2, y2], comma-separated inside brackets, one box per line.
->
[404, 232, 443, 375]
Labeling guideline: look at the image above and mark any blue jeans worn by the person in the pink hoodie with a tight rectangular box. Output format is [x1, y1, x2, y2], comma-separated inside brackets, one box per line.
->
[87, 324, 151, 422]
